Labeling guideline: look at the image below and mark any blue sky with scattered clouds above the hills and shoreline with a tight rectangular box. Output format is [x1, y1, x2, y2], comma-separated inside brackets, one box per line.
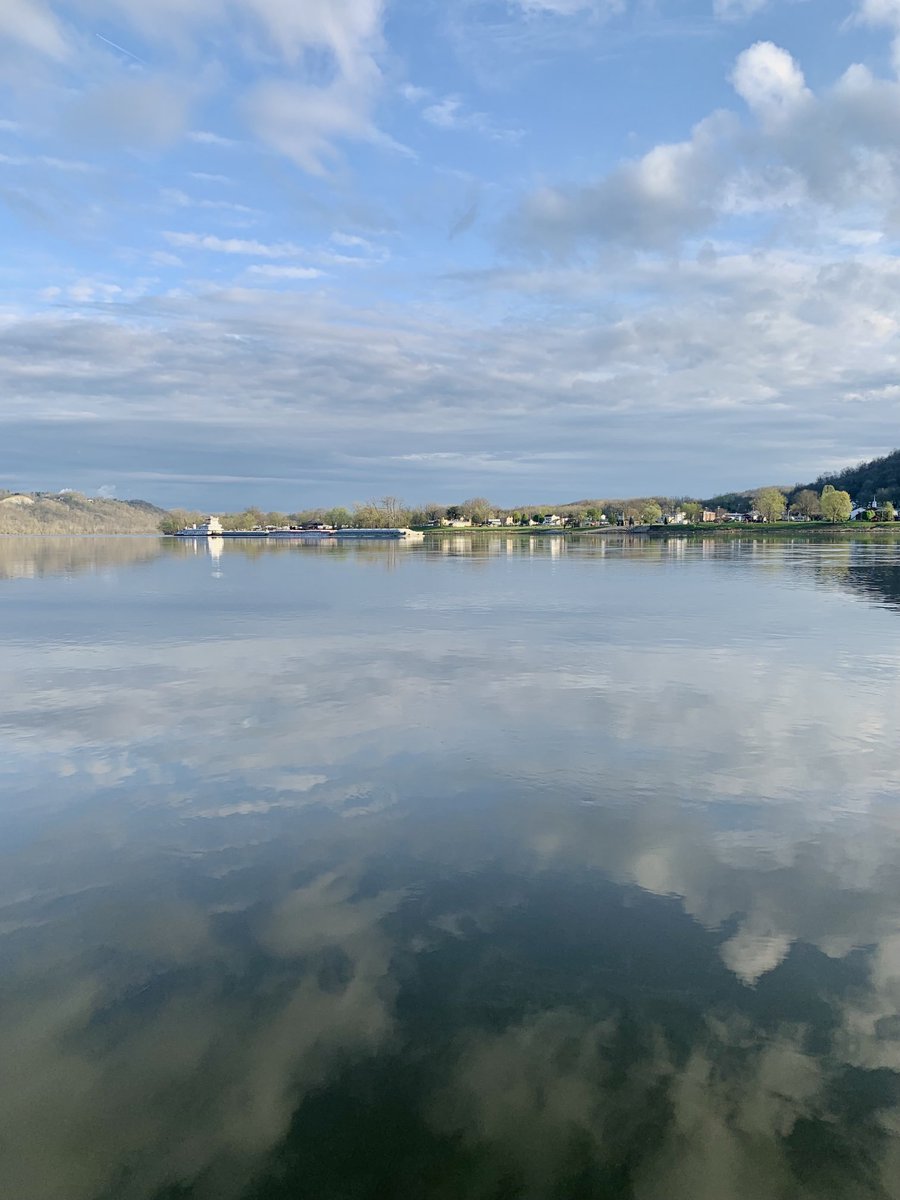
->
[0, 0, 900, 510]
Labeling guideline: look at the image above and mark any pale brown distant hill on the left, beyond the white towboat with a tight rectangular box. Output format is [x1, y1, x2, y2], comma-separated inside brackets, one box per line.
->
[0, 492, 166, 534]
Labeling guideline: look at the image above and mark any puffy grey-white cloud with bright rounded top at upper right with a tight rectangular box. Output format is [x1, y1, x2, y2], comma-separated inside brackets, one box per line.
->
[514, 42, 900, 253]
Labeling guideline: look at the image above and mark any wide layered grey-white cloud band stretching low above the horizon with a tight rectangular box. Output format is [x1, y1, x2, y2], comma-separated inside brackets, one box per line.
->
[0, 243, 900, 503]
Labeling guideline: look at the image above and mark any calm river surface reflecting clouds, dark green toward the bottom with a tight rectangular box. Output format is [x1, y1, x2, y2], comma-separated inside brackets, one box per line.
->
[0, 536, 900, 1200]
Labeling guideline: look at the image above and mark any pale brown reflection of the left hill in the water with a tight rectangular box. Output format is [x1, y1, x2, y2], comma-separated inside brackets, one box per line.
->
[0, 536, 162, 580]
